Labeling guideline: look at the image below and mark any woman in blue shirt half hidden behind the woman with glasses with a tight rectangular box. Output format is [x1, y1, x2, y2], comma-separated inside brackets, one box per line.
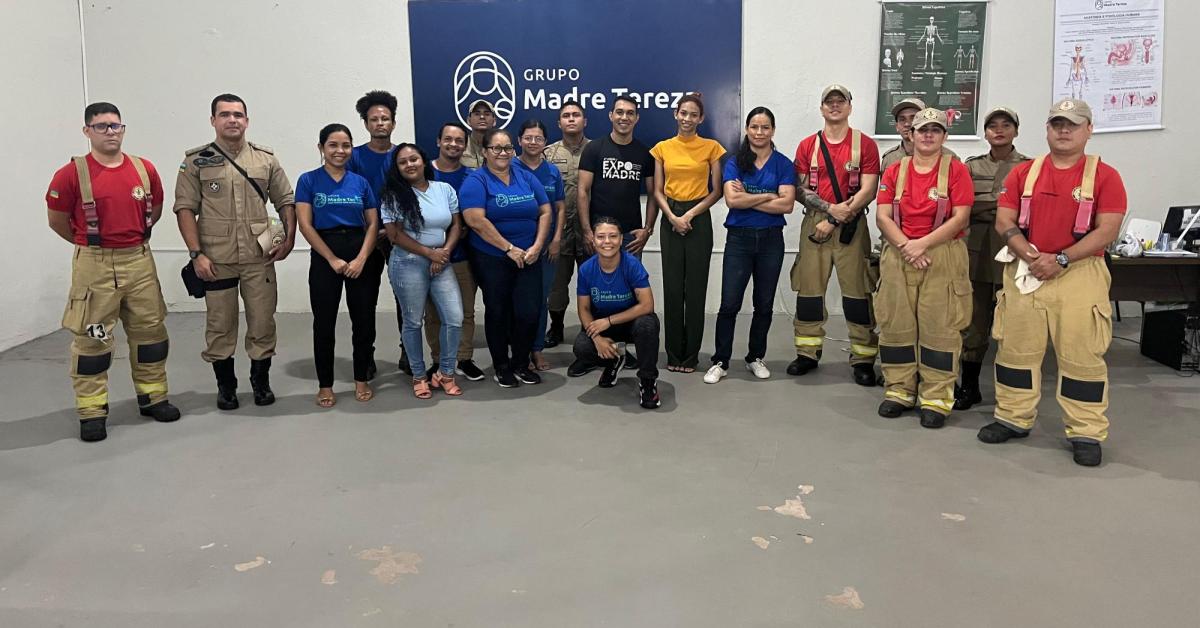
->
[512, 120, 566, 371]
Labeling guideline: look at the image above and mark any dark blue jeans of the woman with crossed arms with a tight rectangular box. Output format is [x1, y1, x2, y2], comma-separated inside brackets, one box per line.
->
[713, 227, 784, 369]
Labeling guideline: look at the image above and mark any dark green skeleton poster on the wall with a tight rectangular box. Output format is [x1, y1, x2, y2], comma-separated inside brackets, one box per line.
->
[875, 1, 988, 137]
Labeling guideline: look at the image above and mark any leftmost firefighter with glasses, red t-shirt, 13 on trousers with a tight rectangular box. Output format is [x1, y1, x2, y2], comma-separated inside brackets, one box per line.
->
[46, 102, 179, 441]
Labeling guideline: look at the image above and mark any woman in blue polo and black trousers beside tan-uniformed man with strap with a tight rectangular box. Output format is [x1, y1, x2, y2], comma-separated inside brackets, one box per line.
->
[296, 124, 383, 408]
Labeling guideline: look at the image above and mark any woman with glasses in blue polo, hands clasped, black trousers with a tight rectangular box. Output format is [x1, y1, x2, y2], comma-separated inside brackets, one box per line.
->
[458, 128, 550, 388]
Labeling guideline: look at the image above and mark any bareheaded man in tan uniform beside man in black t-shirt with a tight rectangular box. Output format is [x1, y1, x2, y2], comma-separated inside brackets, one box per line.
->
[542, 101, 590, 348]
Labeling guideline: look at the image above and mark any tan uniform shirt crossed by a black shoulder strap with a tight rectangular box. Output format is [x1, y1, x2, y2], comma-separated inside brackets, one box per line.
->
[173, 142, 295, 264]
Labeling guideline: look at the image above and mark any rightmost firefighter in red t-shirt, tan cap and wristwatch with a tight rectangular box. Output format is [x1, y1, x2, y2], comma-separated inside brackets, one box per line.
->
[979, 98, 1127, 466]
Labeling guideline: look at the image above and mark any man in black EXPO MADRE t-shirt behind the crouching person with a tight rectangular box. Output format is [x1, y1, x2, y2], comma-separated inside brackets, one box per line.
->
[578, 96, 659, 257]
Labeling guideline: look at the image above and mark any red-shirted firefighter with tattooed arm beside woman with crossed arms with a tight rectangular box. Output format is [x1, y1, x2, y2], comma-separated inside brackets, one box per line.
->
[787, 84, 880, 385]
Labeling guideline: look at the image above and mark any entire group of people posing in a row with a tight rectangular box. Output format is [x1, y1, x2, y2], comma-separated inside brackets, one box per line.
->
[39, 84, 1126, 465]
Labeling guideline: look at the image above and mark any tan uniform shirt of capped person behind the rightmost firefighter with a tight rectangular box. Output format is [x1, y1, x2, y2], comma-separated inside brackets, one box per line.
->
[966, 149, 1030, 283]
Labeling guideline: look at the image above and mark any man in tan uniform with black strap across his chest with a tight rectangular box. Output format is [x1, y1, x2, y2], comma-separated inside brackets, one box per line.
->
[174, 94, 296, 409]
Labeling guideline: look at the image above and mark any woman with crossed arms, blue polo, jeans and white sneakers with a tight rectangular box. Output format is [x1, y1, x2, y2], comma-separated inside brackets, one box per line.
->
[704, 107, 796, 384]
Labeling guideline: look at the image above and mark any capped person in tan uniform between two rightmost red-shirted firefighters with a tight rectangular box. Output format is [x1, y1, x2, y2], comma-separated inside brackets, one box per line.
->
[954, 107, 1030, 409]
